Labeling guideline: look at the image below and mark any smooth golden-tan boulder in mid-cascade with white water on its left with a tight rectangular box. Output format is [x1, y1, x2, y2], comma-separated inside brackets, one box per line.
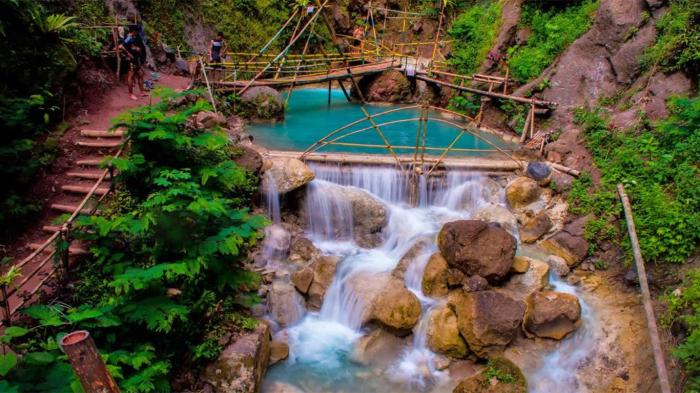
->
[372, 278, 421, 335]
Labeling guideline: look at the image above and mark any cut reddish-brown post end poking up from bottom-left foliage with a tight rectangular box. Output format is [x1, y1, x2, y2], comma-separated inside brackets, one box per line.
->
[61, 330, 119, 393]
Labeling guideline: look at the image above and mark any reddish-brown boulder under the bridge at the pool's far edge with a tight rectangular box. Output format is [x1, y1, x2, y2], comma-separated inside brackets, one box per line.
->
[352, 70, 412, 103]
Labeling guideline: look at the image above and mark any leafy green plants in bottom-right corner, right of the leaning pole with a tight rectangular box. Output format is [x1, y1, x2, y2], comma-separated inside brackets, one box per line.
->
[664, 270, 700, 392]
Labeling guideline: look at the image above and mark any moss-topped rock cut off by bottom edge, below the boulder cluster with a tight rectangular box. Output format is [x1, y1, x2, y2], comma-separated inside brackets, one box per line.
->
[452, 357, 527, 393]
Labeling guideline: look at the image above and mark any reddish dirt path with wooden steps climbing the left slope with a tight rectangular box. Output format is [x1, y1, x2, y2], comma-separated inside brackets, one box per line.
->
[5, 75, 190, 324]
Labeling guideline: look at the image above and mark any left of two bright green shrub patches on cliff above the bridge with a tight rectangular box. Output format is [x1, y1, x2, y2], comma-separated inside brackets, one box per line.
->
[449, 1, 502, 74]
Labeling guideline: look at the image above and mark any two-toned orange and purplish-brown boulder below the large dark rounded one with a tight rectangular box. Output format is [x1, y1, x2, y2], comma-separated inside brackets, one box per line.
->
[448, 290, 525, 357]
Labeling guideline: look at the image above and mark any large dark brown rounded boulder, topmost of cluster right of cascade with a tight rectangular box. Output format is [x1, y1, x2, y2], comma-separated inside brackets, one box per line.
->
[438, 220, 517, 284]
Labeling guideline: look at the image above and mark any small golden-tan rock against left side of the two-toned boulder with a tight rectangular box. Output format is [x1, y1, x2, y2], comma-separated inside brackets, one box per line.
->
[426, 305, 469, 359]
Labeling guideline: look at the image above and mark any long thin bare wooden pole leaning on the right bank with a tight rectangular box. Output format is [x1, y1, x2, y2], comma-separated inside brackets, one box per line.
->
[617, 183, 671, 393]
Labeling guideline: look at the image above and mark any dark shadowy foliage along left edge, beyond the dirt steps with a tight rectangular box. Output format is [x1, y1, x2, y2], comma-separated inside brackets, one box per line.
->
[0, 0, 102, 237]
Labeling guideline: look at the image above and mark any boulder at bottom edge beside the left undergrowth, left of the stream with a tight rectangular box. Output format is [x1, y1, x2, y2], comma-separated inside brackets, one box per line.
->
[201, 322, 270, 393]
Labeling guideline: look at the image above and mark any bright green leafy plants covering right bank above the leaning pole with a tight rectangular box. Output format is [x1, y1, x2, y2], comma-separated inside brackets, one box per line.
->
[570, 98, 700, 263]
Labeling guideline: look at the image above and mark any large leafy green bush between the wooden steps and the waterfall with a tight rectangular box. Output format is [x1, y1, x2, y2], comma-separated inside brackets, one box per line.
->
[0, 92, 266, 392]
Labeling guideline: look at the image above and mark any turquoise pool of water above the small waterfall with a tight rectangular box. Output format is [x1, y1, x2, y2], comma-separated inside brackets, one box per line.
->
[247, 88, 509, 155]
